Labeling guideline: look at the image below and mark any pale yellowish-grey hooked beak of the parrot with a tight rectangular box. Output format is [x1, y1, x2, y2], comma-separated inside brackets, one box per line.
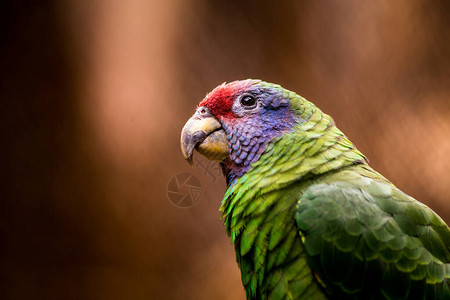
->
[181, 112, 228, 165]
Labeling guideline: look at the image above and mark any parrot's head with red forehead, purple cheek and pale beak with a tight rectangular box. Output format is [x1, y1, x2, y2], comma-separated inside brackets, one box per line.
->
[181, 79, 304, 181]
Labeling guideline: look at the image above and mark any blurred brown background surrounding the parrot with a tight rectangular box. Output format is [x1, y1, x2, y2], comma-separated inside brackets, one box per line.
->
[0, 0, 450, 299]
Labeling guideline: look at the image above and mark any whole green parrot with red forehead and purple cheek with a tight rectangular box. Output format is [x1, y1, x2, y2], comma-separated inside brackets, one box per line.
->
[181, 79, 450, 300]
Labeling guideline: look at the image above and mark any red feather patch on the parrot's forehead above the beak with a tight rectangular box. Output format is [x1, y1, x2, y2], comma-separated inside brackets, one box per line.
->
[199, 80, 252, 117]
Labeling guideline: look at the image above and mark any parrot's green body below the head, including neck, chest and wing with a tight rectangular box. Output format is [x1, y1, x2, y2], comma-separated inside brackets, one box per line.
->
[221, 85, 450, 299]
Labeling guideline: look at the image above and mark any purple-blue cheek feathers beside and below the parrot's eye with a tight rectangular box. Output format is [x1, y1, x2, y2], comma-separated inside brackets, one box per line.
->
[222, 95, 300, 185]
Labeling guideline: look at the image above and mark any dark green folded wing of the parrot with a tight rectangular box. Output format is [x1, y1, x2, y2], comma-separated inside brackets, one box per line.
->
[295, 168, 450, 299]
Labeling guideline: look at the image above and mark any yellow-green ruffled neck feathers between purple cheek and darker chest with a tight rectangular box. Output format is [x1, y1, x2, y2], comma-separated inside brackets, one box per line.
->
[220, 106, 366, 239]
